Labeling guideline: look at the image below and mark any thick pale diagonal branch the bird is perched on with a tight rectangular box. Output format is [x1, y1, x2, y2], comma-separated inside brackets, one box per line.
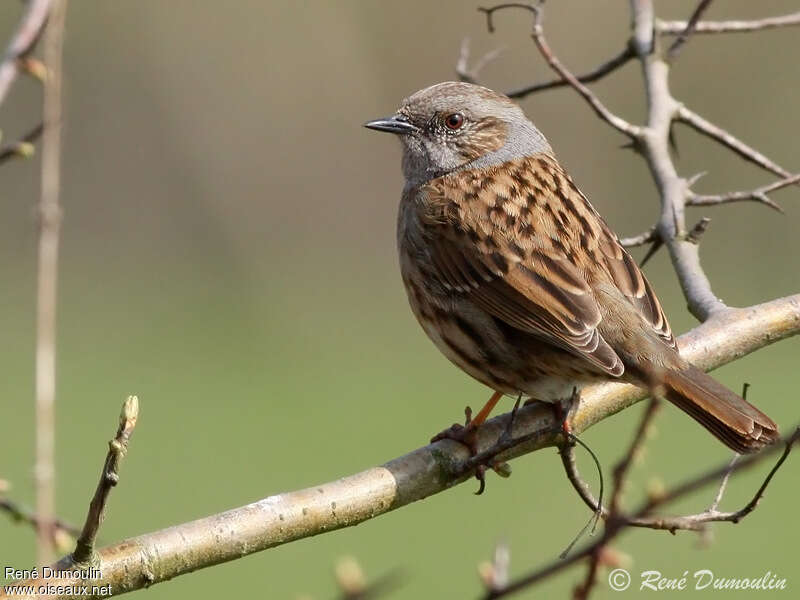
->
[0, 295, 800, 598]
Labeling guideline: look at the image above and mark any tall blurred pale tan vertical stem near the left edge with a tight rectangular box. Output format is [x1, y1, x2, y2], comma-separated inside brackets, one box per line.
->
[35, 0, 66, 564]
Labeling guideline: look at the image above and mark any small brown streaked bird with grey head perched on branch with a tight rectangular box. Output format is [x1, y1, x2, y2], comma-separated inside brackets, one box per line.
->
[365, 81, 778, 454]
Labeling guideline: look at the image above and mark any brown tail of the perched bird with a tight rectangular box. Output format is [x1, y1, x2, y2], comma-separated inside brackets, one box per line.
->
[664, 364, 779, 454]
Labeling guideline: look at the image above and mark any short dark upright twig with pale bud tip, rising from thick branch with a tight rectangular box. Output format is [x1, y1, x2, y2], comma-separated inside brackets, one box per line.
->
[72, 396, 139, 565]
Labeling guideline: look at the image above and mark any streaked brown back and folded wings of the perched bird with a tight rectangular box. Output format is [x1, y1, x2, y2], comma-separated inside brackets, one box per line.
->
[421, 155, 674, 376]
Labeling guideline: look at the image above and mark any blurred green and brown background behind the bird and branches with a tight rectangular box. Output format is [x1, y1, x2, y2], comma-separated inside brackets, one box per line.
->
[0, 0, 800, 599]
